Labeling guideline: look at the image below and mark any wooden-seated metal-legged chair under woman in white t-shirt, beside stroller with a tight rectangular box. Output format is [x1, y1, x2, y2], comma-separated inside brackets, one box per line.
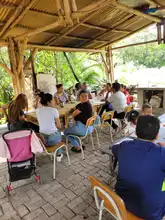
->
[40, 140, 71, 179]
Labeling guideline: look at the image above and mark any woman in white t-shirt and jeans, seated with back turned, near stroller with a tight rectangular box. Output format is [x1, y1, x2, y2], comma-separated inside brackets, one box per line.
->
[36, 93, 63, 162]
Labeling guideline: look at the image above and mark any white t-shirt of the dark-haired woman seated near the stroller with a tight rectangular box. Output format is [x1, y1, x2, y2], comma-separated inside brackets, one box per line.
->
[36, 107, 59, 134]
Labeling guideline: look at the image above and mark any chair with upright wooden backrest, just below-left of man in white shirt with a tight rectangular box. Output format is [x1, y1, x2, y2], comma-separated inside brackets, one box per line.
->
[101, 111, 114, 142]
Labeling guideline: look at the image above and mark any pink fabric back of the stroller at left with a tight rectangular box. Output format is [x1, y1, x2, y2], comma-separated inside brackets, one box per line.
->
[2, 130, 33, 162]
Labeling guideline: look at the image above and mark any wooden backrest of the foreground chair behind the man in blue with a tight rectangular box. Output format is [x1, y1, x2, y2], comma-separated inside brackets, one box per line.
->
[89, 176, 127, 220]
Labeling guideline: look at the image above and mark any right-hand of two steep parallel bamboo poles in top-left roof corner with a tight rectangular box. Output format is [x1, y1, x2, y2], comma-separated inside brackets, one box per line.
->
[3, 0, 36, 36]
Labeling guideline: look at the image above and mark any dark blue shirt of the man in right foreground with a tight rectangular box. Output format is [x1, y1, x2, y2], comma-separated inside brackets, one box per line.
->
[112, 140, 165, 220]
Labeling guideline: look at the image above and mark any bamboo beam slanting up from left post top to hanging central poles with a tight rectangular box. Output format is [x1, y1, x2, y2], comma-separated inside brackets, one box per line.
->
[15, 20, 61, 40]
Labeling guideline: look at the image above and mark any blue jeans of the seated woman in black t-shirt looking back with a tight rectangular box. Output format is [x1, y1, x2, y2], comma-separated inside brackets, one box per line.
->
[64, 121, 94, 147]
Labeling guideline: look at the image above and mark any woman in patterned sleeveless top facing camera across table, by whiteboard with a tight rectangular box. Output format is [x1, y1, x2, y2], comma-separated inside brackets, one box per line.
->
[54, 84, 68, 105]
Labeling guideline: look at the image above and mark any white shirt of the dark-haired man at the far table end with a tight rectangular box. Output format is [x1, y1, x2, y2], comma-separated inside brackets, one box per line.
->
[107, 91, 127, 113]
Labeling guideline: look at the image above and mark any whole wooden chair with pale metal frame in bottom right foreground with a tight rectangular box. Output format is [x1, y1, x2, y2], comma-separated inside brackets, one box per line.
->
[89, 176, 143, 220]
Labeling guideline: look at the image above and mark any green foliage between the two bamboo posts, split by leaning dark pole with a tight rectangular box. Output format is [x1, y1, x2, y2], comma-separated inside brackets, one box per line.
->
[35, 51, 105, 88]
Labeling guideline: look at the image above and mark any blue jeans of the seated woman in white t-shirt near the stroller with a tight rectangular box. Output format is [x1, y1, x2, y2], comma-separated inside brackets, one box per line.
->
[41, 131, 62, 154]
